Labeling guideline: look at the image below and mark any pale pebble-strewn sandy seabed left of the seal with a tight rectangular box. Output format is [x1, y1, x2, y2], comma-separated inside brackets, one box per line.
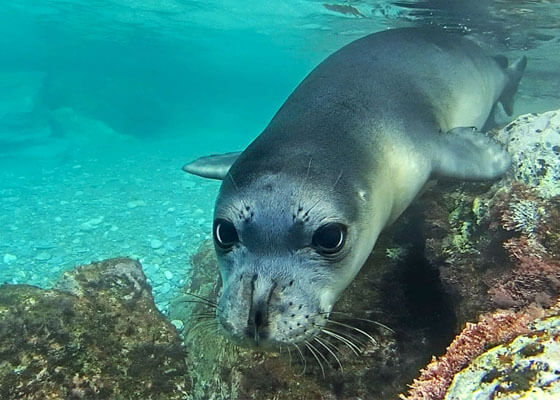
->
[0, 139, 219, 312]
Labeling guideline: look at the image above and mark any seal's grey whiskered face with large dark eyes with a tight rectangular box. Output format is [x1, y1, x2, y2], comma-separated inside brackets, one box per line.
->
[213, 176, 359, 347]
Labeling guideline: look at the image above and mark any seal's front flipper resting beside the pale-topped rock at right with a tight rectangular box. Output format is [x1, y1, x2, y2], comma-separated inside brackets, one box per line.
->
[431, 128, 511, 180]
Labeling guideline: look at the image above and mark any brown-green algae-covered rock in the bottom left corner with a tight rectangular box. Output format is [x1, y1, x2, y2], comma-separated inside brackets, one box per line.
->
[0, 258, 190, 400]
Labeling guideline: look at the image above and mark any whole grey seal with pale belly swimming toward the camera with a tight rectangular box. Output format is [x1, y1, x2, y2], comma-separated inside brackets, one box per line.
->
[184, 29, 526, 345]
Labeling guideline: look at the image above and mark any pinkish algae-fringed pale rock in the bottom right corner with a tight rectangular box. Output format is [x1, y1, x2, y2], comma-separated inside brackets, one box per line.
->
[401, 302, 560, 400]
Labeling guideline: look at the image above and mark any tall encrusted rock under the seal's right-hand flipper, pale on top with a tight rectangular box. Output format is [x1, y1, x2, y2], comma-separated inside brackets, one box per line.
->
[419, 112, 560, 328]
